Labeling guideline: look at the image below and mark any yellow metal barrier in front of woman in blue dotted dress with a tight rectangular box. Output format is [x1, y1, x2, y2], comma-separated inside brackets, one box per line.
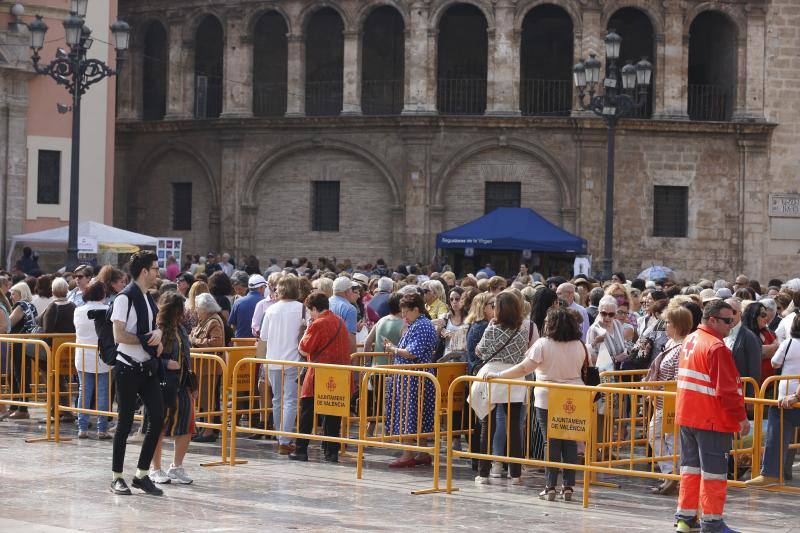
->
[230, 358, 441, 494]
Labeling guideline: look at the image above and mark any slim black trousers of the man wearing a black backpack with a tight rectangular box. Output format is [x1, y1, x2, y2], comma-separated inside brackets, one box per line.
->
[111, 361, 164, 473]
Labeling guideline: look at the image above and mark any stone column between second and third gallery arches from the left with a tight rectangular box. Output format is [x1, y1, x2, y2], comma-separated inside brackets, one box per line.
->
[222, 17, 253, 118]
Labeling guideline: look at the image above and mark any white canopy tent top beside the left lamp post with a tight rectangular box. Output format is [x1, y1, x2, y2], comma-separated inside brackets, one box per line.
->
[6, 220, 158, 270]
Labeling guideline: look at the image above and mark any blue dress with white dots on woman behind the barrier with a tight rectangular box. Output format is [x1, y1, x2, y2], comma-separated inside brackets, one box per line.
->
[384, 316, 437, 435]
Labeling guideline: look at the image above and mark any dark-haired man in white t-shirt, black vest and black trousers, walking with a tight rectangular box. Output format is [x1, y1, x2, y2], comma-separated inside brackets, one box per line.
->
[111, 250, 164, 496]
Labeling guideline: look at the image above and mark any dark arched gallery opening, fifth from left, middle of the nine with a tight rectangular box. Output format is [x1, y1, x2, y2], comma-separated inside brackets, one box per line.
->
[361, 6, 405, 115]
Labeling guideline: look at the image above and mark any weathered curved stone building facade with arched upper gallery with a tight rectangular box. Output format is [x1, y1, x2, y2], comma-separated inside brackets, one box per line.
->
[114, 0, 800, 281]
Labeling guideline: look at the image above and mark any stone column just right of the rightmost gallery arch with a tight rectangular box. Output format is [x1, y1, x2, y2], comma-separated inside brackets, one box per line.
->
[733, 11, 766, 122]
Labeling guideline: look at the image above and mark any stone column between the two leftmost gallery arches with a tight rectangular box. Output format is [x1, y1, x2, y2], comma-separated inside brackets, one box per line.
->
[164, 16, 194, 120]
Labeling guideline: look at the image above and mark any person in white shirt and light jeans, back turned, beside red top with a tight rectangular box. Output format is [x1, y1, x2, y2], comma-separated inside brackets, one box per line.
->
[256, 275, 305, 455]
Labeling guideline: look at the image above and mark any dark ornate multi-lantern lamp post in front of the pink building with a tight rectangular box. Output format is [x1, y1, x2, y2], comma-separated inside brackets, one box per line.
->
[28, 0, 131, 270]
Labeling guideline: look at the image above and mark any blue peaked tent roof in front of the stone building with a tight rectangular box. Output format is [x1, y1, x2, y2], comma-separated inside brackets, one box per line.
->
[436, 207, 586, 254]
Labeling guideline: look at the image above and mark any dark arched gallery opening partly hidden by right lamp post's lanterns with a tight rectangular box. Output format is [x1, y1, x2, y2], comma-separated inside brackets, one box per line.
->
[608, 7, 656, 118]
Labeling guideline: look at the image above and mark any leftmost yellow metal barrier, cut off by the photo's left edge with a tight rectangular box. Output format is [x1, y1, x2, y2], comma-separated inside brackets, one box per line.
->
[0, 335, 53, 442]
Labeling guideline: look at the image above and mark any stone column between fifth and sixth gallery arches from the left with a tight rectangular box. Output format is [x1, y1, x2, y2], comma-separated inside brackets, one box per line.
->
[403, 0, 436, 115]
